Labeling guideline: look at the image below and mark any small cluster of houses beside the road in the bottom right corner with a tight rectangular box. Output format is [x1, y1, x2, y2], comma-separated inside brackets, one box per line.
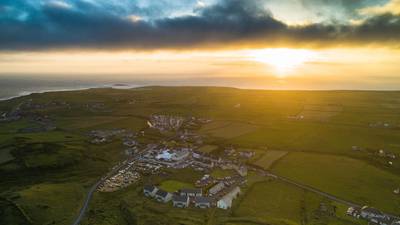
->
[347, 206, 400, 225]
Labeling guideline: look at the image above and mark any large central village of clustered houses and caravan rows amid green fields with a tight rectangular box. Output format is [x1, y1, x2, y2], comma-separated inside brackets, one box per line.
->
[89, 115, 248, 209]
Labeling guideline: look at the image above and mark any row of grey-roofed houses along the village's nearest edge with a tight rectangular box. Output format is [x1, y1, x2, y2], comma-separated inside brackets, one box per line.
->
[143, 185, 240, 209]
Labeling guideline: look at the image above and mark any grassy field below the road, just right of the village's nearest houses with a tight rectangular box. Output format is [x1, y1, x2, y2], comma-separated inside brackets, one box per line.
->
[234, 181, 361, 225]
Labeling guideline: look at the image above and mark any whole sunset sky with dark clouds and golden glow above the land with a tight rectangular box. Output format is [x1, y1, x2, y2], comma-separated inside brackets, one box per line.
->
[0, 0, 400, 89]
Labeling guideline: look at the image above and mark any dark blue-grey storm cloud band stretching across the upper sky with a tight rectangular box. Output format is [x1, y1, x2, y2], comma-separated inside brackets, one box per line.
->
[0, 0, 400, 50]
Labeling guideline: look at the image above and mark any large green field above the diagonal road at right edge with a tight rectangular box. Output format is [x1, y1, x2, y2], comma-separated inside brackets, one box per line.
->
[272, 152, 400, 214]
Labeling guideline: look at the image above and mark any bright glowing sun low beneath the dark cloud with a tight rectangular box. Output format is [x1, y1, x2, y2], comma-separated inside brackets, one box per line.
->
[249, 48, 316, 76]
